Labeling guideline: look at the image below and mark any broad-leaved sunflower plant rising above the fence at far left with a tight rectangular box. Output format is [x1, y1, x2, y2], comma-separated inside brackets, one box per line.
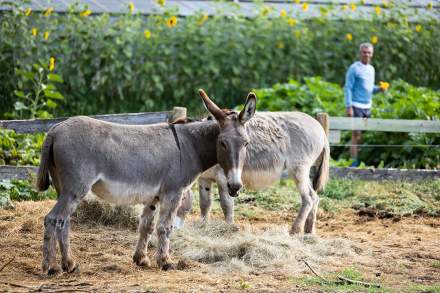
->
[6, 59, 64, 119]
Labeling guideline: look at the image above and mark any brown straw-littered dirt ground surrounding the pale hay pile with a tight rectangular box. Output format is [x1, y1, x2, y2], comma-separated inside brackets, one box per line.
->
[0, 200, 440, 292]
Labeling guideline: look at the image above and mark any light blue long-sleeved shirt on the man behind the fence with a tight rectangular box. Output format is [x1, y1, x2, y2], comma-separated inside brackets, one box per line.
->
[344, 61, 379, 109]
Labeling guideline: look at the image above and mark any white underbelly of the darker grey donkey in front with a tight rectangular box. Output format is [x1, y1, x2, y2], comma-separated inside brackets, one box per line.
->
[92, 179, 160, 204]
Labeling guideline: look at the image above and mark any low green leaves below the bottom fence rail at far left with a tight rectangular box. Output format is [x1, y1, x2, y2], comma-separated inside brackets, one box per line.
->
[0, 180, 57, 207]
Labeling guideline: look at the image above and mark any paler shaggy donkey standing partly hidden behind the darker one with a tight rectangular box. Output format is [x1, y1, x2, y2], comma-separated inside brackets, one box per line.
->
[176, 112, 330, 234]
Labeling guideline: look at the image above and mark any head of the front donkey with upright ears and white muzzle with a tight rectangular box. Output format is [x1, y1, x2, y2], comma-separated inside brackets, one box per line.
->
[199, 90, 257, 197]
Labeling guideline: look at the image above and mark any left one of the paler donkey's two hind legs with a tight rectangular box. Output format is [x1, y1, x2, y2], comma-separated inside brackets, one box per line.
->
[290, 167, 313, 234]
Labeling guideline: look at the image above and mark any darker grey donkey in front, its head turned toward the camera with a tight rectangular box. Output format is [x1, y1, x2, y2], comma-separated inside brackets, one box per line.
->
[37, 90, 256, 275]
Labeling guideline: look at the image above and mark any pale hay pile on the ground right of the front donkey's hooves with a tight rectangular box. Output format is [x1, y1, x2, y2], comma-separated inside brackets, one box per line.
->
[171, 221, 360, 273]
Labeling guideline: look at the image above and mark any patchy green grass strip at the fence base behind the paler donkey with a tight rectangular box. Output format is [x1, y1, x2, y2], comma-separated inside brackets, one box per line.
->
[230, 179, 440, 217]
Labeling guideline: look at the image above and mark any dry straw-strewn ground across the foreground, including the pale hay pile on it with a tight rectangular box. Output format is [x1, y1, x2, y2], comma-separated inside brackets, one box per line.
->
[0, 200, 440, 292]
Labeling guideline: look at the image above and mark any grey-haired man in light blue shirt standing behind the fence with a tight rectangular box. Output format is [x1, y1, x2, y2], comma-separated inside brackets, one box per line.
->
[344, 43, 385, 167]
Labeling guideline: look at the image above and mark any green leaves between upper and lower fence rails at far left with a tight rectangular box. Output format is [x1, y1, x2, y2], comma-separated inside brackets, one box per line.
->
[0, 129, 45, 166]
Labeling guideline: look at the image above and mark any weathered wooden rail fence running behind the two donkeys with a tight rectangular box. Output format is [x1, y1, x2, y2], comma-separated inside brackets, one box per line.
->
[0, 111, 440, 181]
